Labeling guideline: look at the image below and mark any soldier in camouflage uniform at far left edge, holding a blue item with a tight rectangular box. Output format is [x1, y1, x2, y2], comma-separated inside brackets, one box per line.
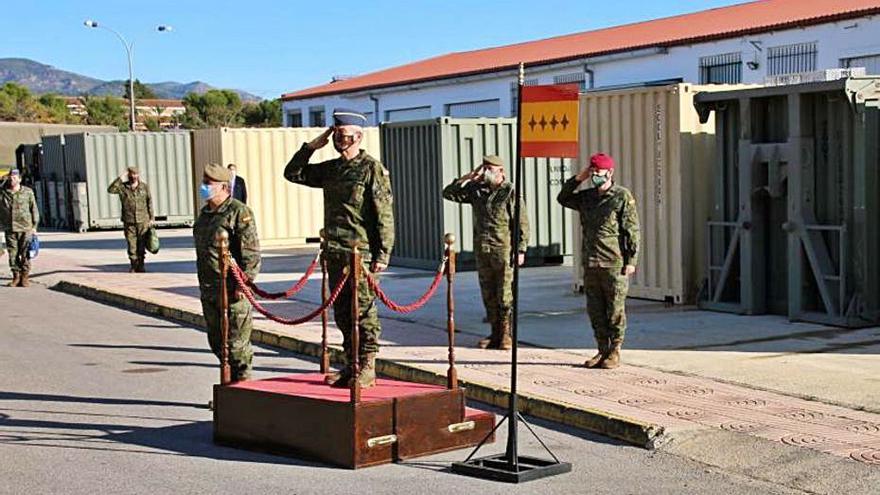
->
[0, 170, 40, 287]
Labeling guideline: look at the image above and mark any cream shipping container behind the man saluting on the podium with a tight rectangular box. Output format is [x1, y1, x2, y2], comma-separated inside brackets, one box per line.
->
[192, 127, 380, 247]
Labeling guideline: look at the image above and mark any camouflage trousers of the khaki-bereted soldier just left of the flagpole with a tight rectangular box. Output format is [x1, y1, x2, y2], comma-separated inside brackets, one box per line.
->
[476, 249, 513, 328]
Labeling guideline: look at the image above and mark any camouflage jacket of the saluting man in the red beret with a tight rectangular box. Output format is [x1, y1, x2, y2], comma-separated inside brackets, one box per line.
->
[556, 177, 639, 268]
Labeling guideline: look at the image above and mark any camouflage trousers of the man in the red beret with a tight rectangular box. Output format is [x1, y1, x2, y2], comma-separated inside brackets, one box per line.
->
[584, 268, 629, 342]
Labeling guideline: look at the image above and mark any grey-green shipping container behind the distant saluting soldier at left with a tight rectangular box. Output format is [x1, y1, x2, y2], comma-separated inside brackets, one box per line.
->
[43, 132, 193, 230]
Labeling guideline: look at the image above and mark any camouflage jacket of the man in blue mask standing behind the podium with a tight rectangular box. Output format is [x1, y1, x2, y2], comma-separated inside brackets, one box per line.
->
[193, 198, 260, 294]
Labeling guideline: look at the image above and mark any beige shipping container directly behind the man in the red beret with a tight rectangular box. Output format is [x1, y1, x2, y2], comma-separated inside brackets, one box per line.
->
[574, 84, 742, 303]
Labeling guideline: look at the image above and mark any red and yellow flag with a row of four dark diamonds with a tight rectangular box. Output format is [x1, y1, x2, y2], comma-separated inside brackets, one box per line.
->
[520, 84, 580, 158]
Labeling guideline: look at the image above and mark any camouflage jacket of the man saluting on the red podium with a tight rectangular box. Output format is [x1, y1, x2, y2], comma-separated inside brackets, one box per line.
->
[284, 145, 394, 264]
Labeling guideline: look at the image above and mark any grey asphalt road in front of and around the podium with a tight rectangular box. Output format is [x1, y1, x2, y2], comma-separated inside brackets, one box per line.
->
[0, 287, 802, 495]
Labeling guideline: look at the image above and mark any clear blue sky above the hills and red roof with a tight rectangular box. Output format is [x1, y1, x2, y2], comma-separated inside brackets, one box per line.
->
[0, 0, 743, 98]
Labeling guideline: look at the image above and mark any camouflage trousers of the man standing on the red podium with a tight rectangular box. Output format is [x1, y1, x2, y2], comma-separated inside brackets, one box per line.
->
[323, 251, 382, 356]
